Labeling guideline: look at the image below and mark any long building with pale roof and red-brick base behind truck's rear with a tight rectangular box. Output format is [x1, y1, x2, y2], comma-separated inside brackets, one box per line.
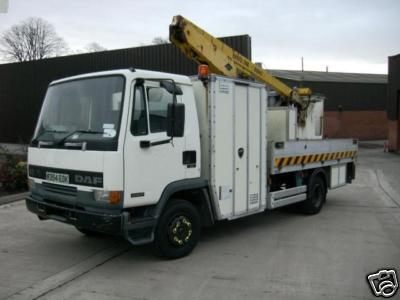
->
[270, 70, 388, 140]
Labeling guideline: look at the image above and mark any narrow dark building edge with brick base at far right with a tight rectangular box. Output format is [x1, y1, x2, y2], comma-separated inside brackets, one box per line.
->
[387, 54, 400, 151]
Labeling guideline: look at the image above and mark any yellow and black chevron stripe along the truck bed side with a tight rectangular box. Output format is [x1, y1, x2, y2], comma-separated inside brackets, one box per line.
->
[275, 151, 357, 168]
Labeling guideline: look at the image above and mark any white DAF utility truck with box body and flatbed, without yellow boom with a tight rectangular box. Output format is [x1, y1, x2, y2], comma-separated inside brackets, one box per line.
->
[26, 69, 357, 258]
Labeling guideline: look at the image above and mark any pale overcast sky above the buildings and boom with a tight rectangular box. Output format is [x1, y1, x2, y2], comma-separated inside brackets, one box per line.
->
[0, 0, 400, 74]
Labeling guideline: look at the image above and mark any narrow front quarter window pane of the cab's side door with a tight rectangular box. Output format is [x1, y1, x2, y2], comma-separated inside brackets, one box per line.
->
[131, 86, 148, 135]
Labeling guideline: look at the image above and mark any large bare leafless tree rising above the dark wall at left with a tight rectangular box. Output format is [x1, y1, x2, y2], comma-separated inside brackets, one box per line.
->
[0, 18, 67, 61]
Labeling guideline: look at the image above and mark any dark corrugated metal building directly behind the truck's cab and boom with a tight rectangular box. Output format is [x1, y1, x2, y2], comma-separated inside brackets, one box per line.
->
[0, 35, 251, 143]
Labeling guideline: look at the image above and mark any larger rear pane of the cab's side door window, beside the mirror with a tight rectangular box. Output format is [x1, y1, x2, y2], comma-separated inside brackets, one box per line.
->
[147, 87, 173, 133]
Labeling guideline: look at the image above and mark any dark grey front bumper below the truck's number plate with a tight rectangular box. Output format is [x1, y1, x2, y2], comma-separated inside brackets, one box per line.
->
[26, 196, 156, 245]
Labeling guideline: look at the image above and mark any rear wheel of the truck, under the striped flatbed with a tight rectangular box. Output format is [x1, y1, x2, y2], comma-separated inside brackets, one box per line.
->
[301, 175, 327, 215]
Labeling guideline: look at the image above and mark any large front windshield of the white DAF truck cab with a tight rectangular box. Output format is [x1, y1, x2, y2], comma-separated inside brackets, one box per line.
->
[34, 75, 124, 150]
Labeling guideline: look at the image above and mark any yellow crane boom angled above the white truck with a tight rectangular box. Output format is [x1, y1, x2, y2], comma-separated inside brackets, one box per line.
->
[169, 16, 311, 119]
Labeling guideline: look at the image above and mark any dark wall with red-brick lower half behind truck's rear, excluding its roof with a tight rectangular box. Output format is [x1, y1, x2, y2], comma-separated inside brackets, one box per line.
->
[282, 79, 388, 140]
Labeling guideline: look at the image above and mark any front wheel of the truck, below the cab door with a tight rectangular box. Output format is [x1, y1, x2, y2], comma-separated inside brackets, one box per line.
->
[154, 200, 201, 259]
